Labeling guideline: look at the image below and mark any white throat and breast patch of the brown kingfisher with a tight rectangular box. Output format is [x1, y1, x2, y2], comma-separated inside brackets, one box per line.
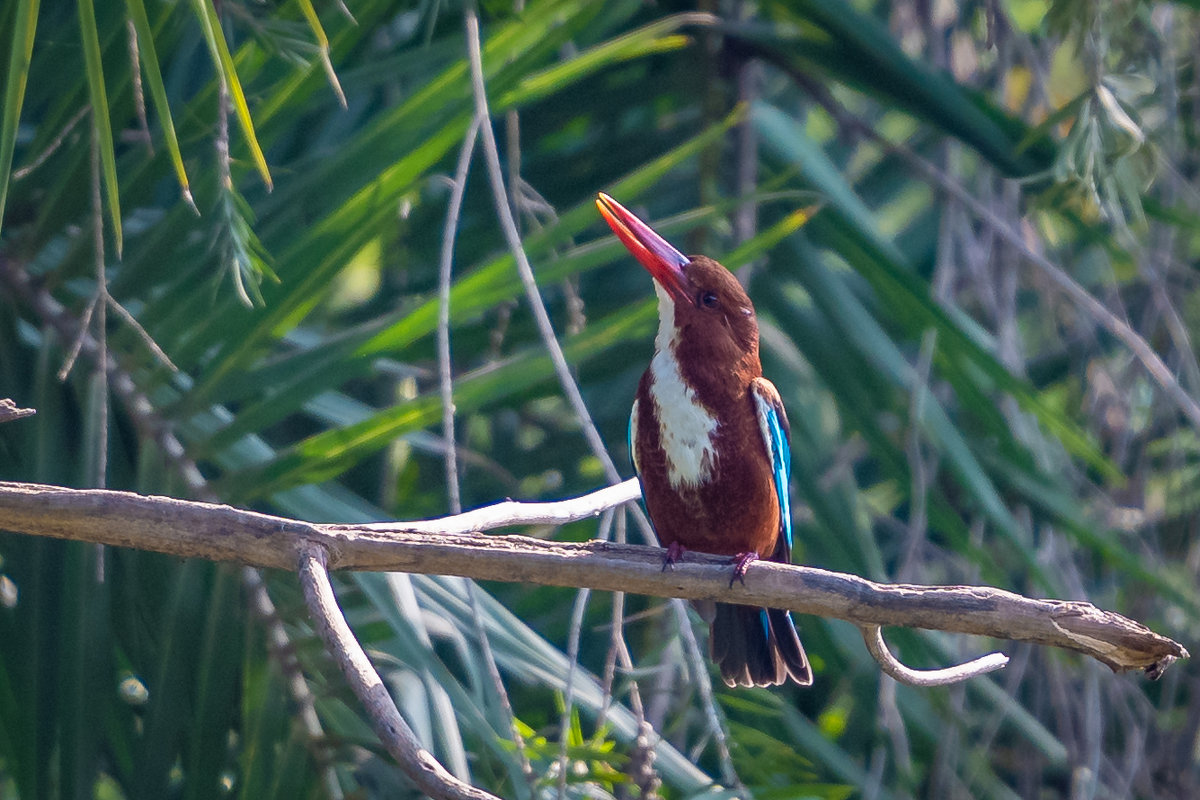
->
[650, 281, 720, 488]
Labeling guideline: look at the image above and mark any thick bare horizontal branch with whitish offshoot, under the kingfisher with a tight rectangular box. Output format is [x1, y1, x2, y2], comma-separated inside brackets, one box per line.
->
[0, 481, 1188, 678]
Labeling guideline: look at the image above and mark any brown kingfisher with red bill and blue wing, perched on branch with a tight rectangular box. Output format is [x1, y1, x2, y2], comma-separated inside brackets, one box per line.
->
[596, 193, 812, 686]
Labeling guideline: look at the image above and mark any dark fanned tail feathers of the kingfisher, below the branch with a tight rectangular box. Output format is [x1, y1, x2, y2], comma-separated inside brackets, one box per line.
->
[709, 603, 812, 686]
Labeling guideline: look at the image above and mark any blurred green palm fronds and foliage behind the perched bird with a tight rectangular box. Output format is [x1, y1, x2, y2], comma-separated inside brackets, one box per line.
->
[0, 0, 1200, 800]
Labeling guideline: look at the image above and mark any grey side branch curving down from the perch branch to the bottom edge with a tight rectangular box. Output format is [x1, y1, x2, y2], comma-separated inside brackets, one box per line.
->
[299, 545, 498, 800]
